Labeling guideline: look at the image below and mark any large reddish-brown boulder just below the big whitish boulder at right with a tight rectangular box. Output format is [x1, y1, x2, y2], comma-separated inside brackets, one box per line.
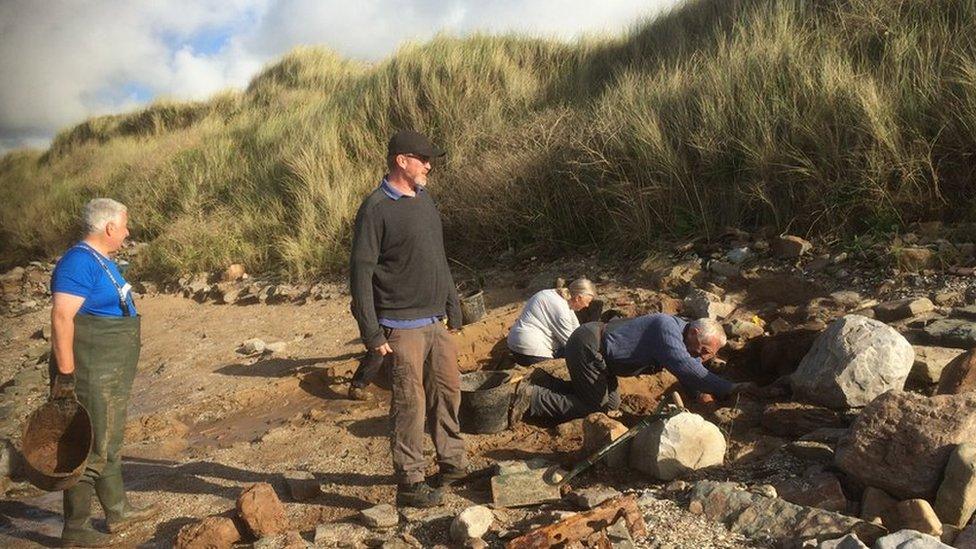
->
[834, 391, 976, 499]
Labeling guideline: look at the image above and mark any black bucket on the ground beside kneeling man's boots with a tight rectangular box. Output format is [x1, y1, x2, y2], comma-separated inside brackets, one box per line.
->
[458, 372, 516, 434]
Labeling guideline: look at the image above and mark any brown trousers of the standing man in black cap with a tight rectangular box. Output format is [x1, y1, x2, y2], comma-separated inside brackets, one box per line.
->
[387, 322, 467, 483]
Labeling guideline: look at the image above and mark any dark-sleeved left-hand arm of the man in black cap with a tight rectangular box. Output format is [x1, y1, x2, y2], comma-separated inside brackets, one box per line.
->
[349, 203, 389, 348]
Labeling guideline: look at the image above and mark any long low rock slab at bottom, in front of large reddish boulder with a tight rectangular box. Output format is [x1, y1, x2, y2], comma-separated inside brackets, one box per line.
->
[688, 480, 885, 545]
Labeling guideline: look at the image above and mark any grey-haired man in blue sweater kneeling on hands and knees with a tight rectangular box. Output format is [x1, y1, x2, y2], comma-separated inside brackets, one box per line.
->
[509, 314, 758, 425]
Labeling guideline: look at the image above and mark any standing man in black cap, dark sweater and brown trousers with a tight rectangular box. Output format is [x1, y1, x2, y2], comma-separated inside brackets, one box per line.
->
[350, 131, 467, 507]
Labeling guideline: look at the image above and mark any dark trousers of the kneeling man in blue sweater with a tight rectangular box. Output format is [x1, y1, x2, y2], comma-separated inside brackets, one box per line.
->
[528, 322, 620, 420]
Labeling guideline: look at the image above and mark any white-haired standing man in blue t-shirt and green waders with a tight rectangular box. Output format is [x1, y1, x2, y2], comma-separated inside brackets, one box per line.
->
[49, 198, 156, 547]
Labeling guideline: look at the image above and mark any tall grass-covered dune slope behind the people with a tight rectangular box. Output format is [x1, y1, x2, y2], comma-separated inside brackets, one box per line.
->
[0, 0, 976, 278]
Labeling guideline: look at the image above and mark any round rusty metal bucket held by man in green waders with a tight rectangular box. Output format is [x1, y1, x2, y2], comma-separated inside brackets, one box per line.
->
[20, 399, 93, 491]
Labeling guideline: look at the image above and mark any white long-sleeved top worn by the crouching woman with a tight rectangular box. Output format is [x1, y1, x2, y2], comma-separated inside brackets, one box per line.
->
[508, 290, 579, 357]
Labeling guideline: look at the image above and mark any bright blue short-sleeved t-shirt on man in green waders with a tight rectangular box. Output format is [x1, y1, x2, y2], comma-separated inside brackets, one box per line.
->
[51, 242, 136, 316]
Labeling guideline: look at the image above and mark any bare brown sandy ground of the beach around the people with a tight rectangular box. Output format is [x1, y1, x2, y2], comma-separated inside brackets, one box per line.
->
[0, 284, 688, 547]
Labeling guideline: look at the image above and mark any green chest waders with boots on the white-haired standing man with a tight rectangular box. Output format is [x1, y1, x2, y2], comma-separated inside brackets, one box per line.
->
[51, 315, 141, 541]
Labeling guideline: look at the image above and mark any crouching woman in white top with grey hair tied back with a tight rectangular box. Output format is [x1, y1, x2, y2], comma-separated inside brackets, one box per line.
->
[507, 278, 596, 366]
